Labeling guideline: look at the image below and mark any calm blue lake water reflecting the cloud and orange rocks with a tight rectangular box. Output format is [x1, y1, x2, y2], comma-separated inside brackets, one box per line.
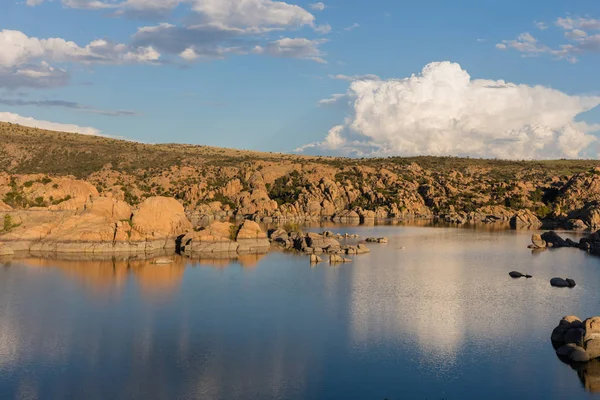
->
[0, 226, 600, 400]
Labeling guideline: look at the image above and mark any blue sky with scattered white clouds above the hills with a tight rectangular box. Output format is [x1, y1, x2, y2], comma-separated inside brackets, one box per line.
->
[0, 0, 600, 159]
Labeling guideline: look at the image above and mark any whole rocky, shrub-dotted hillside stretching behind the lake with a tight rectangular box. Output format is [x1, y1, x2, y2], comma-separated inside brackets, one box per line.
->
[0, 123, 600, 228]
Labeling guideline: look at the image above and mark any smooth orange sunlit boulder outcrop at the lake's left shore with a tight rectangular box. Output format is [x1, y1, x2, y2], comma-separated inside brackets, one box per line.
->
[0, 197, 192, 253]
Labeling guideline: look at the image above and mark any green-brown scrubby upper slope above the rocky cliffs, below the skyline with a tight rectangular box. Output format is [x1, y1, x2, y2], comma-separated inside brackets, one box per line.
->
[0, 122, 600, 178]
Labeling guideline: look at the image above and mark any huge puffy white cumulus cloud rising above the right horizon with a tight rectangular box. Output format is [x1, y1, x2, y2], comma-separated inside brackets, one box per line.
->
[299, 62, 600, 159]
